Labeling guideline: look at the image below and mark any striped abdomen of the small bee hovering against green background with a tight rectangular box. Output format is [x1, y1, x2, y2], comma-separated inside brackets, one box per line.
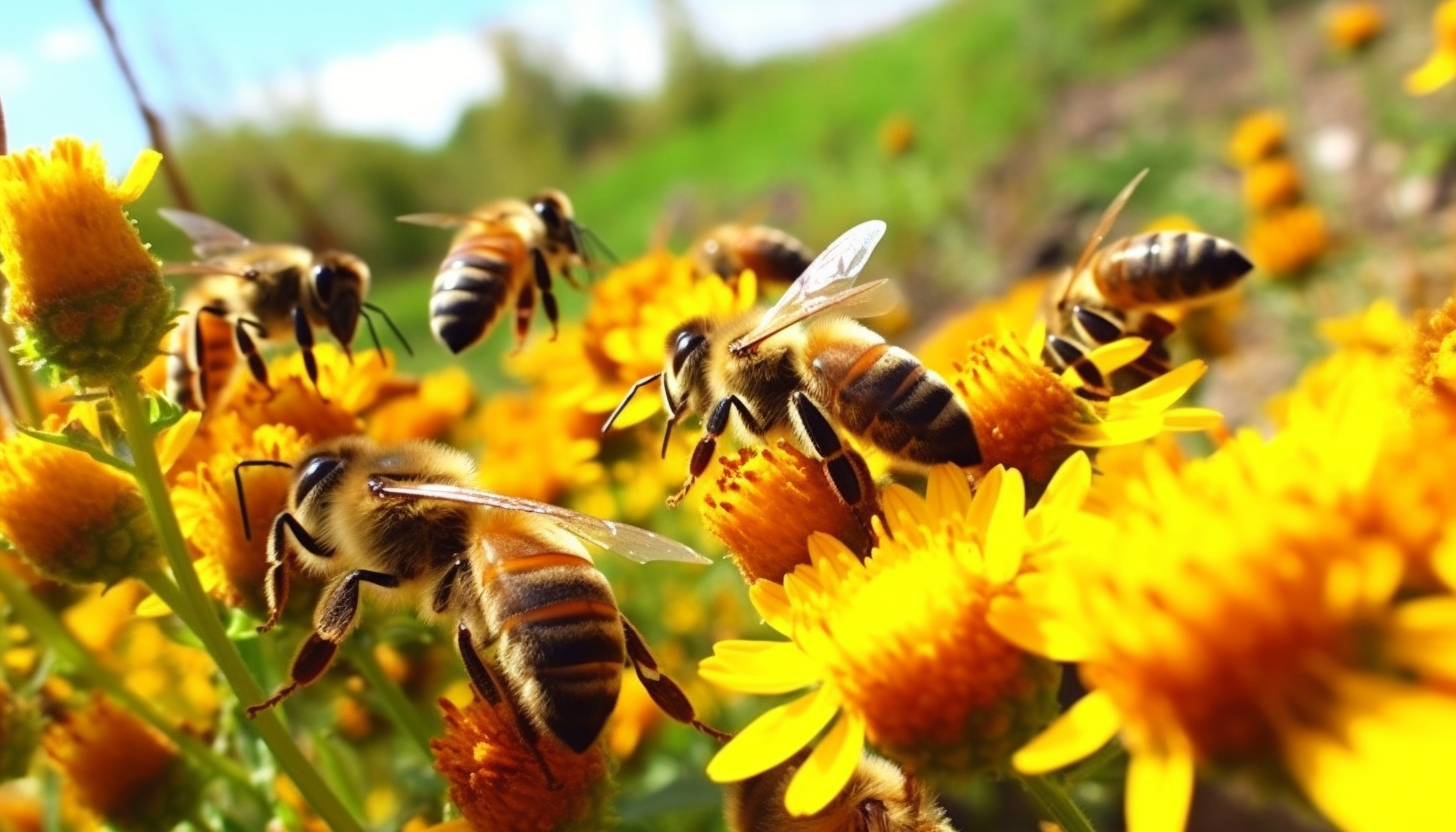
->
[430, 230, 529, 354]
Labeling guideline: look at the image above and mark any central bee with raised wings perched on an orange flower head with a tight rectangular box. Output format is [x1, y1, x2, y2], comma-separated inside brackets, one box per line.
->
[603, 220, 981, 507]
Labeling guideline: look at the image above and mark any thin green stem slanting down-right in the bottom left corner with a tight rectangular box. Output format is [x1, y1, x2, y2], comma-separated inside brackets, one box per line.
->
[0, 570, 256, 804]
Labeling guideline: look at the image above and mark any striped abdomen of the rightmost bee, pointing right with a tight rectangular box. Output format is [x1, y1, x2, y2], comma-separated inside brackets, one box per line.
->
[1088, 232, 1254, 309]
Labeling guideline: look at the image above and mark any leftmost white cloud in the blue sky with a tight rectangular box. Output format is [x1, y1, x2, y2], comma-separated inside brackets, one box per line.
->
[234, 34, 501, 144]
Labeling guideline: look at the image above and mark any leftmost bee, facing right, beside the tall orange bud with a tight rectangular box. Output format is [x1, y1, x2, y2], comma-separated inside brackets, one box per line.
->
[159, 208, 411, 409]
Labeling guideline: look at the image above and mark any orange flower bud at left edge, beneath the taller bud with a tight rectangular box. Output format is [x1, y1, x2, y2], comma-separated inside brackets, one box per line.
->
[0, 418, 162, 586]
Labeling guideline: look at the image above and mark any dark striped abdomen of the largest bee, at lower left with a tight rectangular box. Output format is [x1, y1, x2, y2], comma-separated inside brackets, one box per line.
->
[480, 552, 628, 753]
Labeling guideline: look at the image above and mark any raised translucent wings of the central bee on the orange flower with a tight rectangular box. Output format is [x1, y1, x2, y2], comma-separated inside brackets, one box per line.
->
[728, 220, 897, 353]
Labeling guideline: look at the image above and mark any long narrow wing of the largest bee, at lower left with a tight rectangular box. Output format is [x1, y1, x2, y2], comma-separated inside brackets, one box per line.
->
[370, 478, 712, 564]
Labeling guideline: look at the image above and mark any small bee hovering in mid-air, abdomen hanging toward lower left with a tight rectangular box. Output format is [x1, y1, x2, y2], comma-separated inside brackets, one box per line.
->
[399, 189, 593, 354]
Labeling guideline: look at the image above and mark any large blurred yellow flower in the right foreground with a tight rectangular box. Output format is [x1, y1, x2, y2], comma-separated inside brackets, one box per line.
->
[992, 370, 1456, 832]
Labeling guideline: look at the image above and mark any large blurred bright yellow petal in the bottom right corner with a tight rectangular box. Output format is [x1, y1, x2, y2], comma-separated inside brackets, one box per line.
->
[1286, 678, 1456, 832]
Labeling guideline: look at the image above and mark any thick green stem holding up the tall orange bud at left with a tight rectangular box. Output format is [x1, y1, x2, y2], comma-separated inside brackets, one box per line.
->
[112, 377, 364, 832]
